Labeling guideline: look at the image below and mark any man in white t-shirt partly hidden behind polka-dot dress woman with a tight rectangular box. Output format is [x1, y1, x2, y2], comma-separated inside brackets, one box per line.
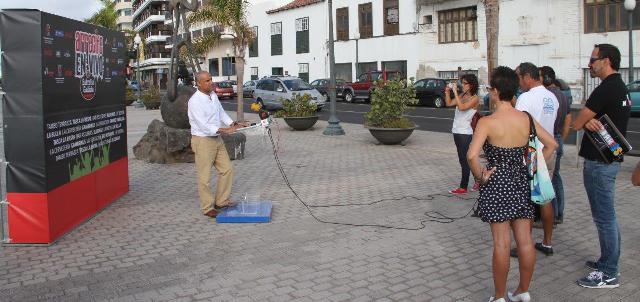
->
[511, 62, 559, 256]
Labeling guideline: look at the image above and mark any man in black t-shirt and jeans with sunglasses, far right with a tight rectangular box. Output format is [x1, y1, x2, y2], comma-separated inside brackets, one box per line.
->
[573, 44, 631, 288]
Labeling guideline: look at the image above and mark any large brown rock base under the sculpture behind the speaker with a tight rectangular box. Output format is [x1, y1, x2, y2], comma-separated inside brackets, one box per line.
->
[133, 120, 247, 164]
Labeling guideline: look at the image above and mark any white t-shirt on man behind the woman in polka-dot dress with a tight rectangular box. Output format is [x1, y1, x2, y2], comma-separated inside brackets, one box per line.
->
[516, 85, 559, 135]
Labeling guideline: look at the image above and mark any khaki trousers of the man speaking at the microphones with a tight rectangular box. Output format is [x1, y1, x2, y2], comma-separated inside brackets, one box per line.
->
[191, 136, 233, 213]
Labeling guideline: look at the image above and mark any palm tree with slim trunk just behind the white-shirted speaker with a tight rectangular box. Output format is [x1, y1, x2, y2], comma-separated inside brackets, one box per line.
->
[188, 0, 254, 121]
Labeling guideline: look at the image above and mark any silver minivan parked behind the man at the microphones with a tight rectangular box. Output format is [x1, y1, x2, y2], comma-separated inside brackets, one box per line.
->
[253, 77, 325, 111]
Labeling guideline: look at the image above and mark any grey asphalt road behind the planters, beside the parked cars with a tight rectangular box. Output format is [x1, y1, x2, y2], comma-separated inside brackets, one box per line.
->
[221, 99, 640, 156]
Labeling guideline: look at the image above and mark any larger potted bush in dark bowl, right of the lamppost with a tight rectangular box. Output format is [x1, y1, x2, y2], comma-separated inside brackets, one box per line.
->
[364, 79, 418, 145]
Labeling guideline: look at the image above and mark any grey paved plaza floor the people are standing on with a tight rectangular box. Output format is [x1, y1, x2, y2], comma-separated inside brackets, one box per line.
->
[0, 107, 640, 302]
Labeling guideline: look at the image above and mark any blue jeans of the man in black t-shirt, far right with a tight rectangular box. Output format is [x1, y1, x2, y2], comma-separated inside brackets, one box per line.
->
[582, 159, 621, 277]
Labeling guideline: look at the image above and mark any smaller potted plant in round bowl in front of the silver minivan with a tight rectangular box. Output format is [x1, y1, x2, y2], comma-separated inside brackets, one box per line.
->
[276, 93, 318, 130]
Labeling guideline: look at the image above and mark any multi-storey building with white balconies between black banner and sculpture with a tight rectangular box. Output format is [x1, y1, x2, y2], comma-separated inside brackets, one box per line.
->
[132, 0, 172, 89]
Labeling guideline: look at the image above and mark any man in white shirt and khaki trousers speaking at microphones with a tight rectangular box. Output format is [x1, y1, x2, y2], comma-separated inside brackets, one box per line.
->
[188, 71, 242, 218]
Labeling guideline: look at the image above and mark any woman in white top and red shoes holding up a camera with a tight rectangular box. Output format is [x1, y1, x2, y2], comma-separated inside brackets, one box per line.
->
[444, 74, 480, 194]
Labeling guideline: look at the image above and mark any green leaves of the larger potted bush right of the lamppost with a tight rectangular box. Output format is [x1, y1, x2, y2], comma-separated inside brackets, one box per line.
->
[365, 79, 418, 128]
